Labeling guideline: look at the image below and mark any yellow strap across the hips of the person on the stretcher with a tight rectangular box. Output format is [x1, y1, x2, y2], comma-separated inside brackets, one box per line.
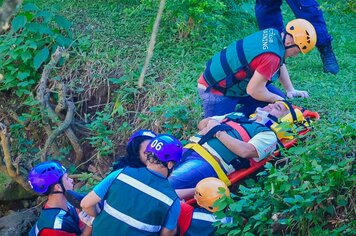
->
[184, 143, 231, 186]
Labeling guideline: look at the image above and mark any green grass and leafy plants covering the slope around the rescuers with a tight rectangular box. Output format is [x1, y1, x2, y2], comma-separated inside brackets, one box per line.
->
[0, 0, 356, 235]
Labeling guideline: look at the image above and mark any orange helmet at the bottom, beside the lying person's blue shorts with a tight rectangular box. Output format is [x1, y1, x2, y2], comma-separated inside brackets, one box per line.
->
[194, 177, 230, 212]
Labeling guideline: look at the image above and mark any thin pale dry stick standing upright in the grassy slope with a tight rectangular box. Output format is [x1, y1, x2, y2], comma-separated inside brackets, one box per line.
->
[138, 0, 166, 88]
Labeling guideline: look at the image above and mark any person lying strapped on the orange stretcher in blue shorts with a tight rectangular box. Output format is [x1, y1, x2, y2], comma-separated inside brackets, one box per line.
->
[168, 101, 308, 199]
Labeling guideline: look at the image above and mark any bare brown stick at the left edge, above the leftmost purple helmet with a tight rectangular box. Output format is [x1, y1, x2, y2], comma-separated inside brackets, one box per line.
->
[0, 123, 31, 191]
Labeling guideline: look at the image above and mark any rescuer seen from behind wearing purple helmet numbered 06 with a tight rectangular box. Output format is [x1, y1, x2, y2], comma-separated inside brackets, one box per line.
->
[81, 134, 182, 235]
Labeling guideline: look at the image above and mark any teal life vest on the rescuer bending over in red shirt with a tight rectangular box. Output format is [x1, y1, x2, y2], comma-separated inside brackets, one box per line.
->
[204, 28, 285, 97]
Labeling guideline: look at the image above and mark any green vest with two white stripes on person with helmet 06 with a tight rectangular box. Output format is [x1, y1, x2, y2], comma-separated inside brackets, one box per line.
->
[93, 167, 178, 236]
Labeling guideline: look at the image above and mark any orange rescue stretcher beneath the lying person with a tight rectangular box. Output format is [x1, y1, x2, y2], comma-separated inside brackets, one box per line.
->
[186, 106, 320, 205]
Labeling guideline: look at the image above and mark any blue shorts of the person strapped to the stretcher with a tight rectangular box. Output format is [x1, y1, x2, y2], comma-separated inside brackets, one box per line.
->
[168, 149, 218, 189]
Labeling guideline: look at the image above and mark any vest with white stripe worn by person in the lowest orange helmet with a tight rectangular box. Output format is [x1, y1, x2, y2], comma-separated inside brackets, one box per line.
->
[184, 208, 233, 236]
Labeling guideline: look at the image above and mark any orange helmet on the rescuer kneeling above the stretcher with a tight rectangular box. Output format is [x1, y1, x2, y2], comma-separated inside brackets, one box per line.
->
[286, 19, 316, 54]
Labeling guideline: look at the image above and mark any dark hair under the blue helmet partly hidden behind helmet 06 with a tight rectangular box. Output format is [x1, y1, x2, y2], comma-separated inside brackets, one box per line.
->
[113, 136, 152, 171]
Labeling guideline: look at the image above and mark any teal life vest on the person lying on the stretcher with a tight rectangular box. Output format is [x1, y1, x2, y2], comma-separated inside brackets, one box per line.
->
[193, 113, 271, 170]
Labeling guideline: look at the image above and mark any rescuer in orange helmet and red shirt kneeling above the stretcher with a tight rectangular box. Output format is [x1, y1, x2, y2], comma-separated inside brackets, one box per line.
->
[198, 19, 317, 118]
